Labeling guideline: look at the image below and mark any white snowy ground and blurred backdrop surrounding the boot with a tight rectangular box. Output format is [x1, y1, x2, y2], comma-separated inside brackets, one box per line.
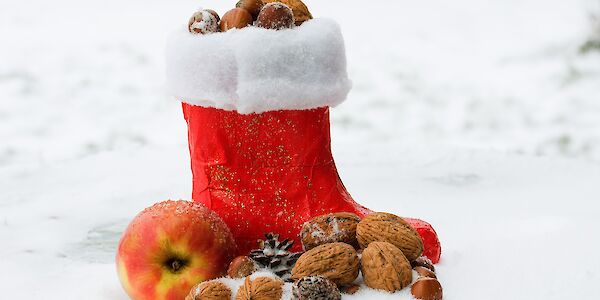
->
[0, 0, 600, 300]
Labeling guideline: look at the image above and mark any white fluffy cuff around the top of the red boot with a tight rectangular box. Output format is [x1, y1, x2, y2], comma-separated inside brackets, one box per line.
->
[166, 19, 352, 114]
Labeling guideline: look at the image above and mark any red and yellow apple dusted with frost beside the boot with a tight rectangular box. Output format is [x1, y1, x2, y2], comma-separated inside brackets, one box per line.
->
[116, 200, 236, 300]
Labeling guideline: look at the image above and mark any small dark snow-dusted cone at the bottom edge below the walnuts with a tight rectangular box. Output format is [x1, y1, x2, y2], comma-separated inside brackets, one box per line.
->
[292, 276, 342, 300]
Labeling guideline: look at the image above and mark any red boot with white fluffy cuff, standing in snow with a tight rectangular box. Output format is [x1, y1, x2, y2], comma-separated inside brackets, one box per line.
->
[167, 20, 439, 261]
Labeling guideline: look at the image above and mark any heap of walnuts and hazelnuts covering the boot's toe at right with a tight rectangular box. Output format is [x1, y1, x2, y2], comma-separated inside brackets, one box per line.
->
[292, 213, 442, 300]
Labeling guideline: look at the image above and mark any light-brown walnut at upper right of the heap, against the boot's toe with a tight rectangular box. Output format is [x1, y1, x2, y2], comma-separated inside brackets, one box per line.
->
[356, 213, 423, 262]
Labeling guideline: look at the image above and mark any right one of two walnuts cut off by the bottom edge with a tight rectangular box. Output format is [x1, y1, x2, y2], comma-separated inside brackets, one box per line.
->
[235, 276, 283, 300]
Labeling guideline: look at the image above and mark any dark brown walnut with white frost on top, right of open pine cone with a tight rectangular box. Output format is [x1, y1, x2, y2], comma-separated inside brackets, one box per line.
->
[300, 212, 360, 251]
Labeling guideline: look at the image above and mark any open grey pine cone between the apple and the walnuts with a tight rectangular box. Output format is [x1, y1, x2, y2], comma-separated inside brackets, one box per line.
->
[249, 233, 302, 281]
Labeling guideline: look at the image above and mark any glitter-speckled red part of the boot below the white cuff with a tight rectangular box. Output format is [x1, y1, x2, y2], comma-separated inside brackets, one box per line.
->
[183, 103, 439, 261]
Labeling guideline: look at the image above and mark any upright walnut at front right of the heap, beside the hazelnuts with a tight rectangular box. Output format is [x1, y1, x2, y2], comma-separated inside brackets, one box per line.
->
[361, 242, 412, 293]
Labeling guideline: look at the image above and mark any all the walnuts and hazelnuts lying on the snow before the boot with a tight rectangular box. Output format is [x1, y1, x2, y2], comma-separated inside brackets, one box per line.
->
[186, 212, 442, 300]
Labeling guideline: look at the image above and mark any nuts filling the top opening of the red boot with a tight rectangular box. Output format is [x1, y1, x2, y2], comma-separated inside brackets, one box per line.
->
[188, 0, 312, 34]
